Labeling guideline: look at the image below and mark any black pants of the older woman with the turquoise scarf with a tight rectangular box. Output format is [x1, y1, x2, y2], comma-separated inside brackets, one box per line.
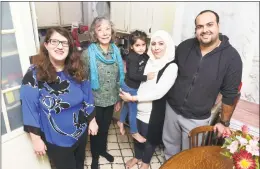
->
[90, 105, 114, 158]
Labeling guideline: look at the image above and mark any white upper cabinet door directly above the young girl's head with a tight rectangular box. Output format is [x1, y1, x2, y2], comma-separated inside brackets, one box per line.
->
[129, 2, 152, 34]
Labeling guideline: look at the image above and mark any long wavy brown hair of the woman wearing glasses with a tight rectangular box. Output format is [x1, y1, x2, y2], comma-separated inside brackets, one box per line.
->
[34, 27, 87, 83]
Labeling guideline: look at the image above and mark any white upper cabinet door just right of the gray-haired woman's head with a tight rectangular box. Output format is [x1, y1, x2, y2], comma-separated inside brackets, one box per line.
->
[110, 2, 129, 32]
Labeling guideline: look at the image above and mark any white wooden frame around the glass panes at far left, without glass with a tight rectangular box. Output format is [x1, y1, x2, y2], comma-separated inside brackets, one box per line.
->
[1, 2, 39, 144]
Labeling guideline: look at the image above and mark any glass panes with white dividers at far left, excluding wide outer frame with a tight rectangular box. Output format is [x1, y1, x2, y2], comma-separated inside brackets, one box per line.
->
[1, 2, 23, 138]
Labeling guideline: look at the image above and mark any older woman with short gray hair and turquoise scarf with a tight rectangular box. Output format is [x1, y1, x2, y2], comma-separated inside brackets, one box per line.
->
[83, 17, 124, 169]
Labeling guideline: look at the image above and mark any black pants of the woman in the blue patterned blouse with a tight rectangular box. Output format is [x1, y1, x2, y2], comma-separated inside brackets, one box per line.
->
[45, 129, 88, 169]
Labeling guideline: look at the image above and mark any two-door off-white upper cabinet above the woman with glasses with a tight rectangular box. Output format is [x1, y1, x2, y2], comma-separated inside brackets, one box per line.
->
[34, 2, 82, 28]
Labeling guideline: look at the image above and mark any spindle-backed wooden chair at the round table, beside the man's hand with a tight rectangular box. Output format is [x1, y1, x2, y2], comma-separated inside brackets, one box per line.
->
[189, 126, 222, 148]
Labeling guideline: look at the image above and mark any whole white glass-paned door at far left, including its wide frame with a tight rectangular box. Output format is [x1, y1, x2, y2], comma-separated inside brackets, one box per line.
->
[0, 2, 36, 142]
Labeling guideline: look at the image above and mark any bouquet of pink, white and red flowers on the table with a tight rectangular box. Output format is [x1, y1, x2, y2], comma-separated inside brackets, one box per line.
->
[221, 125, 259, 169]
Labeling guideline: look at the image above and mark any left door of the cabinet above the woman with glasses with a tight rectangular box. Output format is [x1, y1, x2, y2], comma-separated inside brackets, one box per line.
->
[34, 2, 60, 27]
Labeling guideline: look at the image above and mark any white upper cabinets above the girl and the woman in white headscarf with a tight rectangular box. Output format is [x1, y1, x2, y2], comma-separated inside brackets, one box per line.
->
[111, 2, 176, 35]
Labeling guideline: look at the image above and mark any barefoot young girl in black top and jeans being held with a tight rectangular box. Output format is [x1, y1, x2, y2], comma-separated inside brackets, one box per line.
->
[117, 30, 154, 143]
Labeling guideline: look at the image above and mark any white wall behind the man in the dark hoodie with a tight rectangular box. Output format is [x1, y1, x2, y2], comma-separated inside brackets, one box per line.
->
[173, 2, 259, 104]
